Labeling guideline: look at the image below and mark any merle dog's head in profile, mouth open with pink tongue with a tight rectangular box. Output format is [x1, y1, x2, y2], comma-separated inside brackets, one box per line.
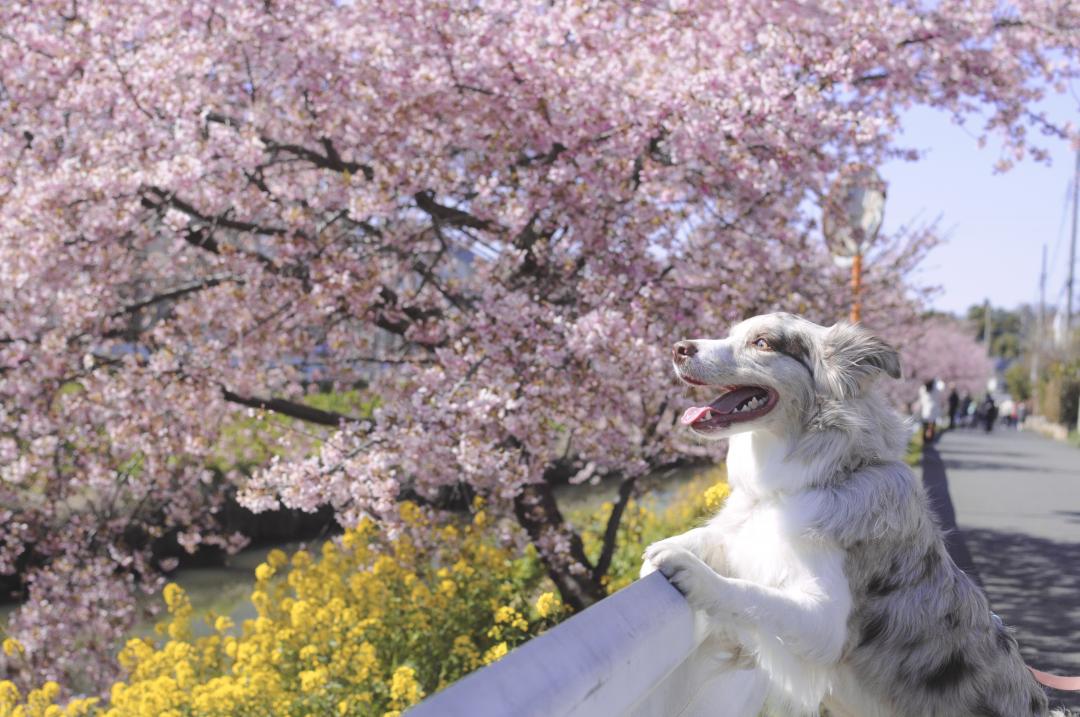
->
[672, 313, 900, 438]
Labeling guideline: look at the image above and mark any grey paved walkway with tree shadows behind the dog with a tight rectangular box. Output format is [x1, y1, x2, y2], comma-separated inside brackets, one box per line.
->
[923, 429, 1080, 707]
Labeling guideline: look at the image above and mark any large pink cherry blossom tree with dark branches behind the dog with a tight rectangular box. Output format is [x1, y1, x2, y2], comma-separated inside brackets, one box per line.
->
[0, 0, 1080, 691]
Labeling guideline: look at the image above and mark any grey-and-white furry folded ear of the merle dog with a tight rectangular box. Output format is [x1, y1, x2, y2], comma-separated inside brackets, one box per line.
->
[816, 322, 901, 398]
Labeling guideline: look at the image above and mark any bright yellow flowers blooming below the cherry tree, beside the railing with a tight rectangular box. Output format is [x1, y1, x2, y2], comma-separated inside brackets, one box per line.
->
[0, 469, 728, 717]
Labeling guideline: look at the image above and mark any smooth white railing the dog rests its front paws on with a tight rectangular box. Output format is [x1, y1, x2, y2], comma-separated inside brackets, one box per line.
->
[406, 572, 703, 717]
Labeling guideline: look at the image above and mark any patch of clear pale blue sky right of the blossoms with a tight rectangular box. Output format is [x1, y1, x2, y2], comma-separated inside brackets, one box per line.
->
[881, 87, 1080, 313]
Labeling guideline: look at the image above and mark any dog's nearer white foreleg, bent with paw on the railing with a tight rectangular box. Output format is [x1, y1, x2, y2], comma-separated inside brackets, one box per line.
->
[645, 541, 851, 664]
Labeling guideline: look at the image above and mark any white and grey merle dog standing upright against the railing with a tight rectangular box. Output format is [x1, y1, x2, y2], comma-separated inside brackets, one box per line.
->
[642, 313, 1059, 717]
